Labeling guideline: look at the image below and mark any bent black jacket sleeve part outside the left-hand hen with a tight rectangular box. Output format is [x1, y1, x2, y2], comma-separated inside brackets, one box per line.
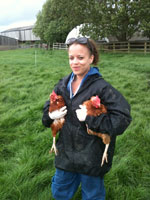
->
[42, 101, 53, 128]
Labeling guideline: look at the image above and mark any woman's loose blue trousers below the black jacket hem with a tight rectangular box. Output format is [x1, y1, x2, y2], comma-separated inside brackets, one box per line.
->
[52, 169, 105, 200]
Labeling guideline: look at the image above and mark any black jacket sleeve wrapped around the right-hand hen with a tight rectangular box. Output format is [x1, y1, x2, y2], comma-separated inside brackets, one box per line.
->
[85, 84, 131, 136]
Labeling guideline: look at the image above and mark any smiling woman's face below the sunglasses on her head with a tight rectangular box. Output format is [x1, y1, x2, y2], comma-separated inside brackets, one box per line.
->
[68, 44, 94, 79]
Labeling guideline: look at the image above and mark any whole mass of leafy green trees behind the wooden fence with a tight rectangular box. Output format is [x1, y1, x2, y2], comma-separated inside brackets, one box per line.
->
[33, 0, 150, 43]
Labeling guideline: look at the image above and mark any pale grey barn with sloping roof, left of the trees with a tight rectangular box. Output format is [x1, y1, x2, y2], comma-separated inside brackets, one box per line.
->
[0, 25, 40, 42]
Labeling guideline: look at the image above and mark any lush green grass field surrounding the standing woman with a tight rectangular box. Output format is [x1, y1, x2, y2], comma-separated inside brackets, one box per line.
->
[0, 49, 150, 200]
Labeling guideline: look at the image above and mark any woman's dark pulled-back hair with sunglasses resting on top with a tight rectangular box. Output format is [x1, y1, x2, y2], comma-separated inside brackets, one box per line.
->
[66, 37, 99, 65]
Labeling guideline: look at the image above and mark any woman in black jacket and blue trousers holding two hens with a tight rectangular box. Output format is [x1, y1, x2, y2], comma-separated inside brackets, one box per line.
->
[42, 37, 131, 200]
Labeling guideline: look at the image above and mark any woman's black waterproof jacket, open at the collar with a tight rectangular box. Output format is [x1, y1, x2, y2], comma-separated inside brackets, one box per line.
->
[42, 71, 131, 177]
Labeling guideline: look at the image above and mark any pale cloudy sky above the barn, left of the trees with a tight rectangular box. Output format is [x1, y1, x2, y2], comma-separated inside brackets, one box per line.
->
[0, 0, 46, 32]
